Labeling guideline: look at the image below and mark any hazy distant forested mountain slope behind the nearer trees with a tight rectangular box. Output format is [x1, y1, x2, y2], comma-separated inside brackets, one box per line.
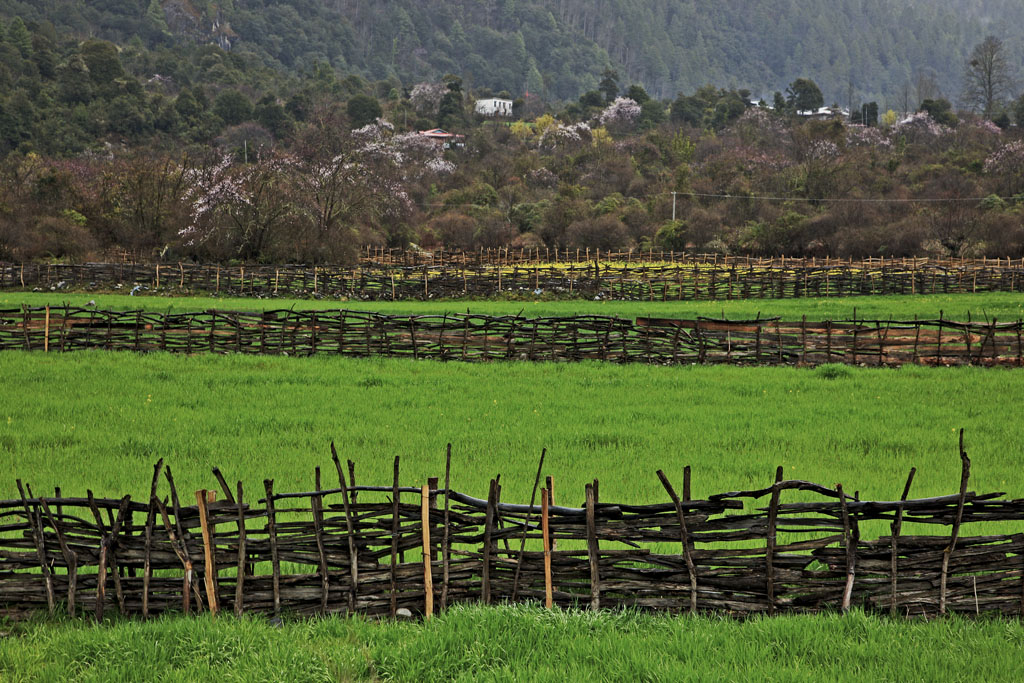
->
[0, 0, 1024, 108]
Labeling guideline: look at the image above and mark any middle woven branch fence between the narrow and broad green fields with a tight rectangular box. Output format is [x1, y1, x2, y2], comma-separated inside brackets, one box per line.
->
[0, 306, 1024, 367]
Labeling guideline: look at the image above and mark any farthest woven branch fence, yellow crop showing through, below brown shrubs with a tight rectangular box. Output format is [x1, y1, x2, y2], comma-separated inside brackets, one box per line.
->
[0, 259, 1024, 301]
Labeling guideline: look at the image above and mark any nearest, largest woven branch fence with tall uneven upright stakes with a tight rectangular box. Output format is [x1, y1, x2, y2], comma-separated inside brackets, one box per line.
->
[0, 434, 1024, 618]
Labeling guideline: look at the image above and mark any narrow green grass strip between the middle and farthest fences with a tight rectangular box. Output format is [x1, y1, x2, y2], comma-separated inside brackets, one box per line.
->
[8, 292, 1024, 322]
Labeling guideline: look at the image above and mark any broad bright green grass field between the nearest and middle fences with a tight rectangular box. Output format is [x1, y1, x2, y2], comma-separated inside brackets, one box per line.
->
[0, 351, 1024, 504]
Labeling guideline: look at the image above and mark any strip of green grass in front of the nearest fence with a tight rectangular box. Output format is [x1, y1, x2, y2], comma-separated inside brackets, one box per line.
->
[0, 607, 1024, 683]
